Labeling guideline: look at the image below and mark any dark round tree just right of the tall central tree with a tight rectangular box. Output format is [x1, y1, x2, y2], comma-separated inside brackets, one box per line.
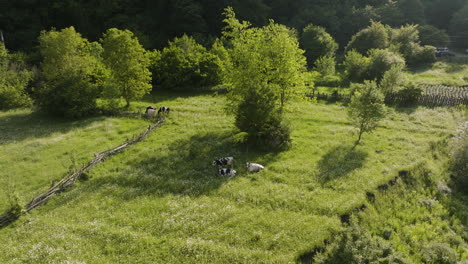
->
[301, 25, 338, 66]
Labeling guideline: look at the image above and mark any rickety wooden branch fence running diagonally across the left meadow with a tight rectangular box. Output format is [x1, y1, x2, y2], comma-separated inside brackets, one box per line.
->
[0, 116, 165, 228]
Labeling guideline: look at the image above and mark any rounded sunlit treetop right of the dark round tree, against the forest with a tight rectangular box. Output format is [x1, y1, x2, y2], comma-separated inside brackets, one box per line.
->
[346, 22, 389, 55]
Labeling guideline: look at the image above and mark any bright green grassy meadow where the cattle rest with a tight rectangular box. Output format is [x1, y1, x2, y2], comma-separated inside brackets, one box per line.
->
[0, 89, 461, 263]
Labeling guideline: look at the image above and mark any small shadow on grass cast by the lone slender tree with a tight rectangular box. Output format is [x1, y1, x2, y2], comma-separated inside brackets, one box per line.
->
[318, 145, 368, 184]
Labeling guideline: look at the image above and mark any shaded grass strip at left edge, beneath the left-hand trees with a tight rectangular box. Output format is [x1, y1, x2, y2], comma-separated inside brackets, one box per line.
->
[0, 112, 104, 145]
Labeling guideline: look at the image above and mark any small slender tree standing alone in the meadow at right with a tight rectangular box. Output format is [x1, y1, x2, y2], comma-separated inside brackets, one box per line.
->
[348, 81, 385, 145]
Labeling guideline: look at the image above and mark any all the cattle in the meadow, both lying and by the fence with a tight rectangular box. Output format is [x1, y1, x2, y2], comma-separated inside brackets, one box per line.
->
[145, 106, 264, 177]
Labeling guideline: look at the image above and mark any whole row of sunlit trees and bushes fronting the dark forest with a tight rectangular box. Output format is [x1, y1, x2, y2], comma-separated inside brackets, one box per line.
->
[0, 7, 452, 148]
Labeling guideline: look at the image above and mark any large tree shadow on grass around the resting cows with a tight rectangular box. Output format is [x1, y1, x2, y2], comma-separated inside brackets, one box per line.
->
[57, 133, 282, 202]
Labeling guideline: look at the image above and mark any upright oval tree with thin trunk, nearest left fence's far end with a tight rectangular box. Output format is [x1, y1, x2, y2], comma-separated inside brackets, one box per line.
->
[101, 28, 152, 107]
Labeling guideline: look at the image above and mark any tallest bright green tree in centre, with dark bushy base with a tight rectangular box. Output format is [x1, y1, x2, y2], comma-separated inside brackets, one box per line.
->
[224, 8, 306, 147]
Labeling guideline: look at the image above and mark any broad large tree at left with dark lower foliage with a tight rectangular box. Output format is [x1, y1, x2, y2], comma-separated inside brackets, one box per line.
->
[38, 27, 100, 117]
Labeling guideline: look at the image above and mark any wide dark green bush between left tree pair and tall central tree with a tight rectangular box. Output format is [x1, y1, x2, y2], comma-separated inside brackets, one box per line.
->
[152, 35, 221, 89]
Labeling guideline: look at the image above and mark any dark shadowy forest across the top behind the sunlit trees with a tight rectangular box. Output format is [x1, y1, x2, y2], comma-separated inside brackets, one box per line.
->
[0, 0, 468, 51]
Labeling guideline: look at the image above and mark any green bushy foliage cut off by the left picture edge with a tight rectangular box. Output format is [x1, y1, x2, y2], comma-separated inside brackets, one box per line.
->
[0, 43, 33, 110]
